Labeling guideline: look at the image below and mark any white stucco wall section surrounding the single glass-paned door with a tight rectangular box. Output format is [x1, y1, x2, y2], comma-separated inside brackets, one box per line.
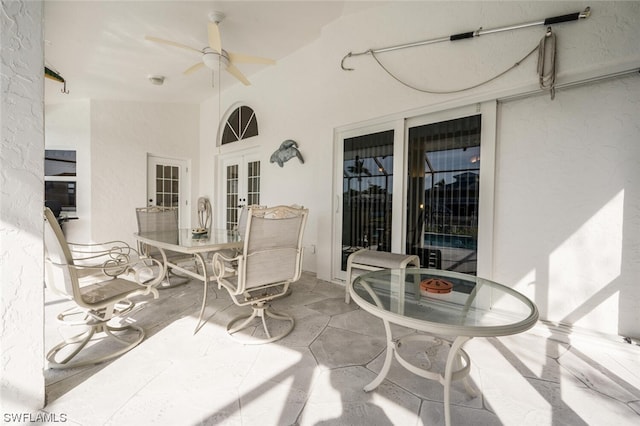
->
[91, 100, 200, 244]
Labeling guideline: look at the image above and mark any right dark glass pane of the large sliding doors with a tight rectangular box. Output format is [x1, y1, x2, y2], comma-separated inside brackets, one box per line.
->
[406, 115, 481, 275]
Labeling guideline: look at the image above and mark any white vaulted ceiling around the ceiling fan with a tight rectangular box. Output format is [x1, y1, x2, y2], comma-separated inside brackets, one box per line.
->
[44, 0, 379, 103]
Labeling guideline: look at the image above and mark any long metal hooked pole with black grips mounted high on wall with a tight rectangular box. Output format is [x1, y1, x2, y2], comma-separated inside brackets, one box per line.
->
[340, 7, 591, 71]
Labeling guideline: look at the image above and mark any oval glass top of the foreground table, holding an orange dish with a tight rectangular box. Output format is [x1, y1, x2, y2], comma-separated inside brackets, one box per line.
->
[350, 268, 538, 336]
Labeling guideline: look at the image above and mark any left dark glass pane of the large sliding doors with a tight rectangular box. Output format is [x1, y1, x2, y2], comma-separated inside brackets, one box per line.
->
[342, 130, 393, 270]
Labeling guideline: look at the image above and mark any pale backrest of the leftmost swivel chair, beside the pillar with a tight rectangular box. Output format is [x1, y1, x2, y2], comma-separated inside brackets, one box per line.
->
[44, 207, 79, 299]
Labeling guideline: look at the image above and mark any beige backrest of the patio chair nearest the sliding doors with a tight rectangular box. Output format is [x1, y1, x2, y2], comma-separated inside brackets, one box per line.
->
[238, 206, 309, 289]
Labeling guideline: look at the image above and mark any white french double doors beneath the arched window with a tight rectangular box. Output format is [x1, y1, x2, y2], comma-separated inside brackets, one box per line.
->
[217, 150, 261, 229]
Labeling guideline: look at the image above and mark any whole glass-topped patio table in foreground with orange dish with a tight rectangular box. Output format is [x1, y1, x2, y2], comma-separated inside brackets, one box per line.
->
[349, 268, 538, 425]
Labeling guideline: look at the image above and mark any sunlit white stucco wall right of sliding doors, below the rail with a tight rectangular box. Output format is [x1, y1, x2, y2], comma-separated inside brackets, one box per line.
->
[494, 75, 640, 336]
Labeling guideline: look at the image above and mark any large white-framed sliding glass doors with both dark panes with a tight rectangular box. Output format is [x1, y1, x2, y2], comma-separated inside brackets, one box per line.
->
[333, 102, 496, 280]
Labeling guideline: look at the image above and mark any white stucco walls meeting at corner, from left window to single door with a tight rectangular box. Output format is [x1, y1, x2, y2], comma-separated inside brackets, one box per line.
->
[45, 99, 200, 244]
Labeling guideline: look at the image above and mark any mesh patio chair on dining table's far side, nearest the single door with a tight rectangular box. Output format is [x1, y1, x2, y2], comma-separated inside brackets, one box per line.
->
[136, 206, 195, 286]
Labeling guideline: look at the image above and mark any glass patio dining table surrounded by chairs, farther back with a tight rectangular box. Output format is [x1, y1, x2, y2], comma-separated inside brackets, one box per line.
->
[133, 229, 243, 333]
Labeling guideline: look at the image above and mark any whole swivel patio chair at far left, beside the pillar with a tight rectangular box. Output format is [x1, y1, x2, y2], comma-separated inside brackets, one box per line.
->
[44, 208, 163, 369]
